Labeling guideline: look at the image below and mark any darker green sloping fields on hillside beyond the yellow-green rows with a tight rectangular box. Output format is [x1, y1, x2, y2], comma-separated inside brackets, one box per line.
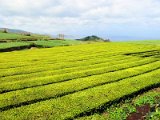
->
[0, 31, 84, 52]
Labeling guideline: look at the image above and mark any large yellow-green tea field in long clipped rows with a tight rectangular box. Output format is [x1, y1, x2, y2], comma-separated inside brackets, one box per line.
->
[0, 43, 160, 120]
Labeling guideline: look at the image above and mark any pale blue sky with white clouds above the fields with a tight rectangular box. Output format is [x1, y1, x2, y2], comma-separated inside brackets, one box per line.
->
[0, 0, 160, 39]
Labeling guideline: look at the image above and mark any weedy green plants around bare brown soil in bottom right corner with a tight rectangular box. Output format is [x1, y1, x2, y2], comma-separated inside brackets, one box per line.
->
[77, 88, 160, 120]
